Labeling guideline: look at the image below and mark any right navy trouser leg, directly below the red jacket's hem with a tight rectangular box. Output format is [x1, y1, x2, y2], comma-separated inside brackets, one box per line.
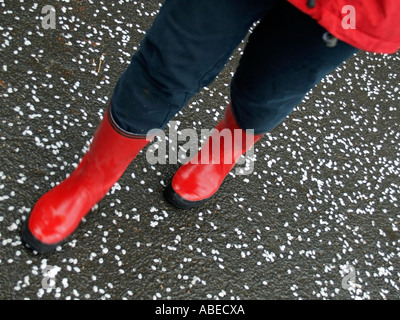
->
[231, 1, 357, 134]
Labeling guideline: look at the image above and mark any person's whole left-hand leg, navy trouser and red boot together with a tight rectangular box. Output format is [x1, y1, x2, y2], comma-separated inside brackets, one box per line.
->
[22, 0, 275, 252]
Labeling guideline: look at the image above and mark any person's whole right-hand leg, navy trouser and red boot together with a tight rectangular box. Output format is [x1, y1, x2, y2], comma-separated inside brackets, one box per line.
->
[165, 0, 357, 208]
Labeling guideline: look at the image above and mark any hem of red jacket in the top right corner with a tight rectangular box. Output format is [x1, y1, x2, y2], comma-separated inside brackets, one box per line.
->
[288, 0, 400, 54]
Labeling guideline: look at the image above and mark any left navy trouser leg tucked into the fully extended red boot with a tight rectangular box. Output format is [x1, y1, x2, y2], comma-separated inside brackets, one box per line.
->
[112, 0, 276, 134]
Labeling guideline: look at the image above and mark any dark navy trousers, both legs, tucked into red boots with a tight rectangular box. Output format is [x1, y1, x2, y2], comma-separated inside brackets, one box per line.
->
[111, 0, 357, 134]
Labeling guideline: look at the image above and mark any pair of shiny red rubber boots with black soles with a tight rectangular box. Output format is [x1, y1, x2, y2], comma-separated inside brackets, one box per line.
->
[22, 106, 261, 253]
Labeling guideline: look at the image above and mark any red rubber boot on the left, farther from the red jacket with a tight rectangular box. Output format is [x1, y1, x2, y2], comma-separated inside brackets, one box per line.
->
[22, 107, 149, 253]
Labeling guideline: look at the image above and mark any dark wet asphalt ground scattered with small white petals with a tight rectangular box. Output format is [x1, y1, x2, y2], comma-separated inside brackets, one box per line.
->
[0, 0, 400, 300]
